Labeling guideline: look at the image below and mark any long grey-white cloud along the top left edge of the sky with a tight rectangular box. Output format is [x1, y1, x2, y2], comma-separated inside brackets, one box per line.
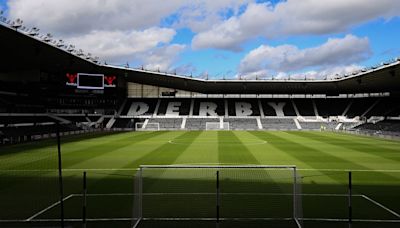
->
[8, 0, 253, 35]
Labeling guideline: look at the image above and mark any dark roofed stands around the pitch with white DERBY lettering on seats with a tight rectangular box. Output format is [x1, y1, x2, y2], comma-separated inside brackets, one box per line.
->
[0, 17, 400, 142]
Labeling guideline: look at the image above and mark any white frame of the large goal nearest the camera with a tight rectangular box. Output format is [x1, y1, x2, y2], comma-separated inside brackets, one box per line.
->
[132, 165, 303, 228]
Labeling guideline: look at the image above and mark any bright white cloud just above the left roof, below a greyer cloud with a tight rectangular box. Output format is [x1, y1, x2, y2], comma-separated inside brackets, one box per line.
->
[68, 28, 185, 71]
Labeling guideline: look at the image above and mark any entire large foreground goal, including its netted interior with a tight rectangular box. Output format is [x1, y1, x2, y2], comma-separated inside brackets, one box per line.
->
[132, 165, 303, 228]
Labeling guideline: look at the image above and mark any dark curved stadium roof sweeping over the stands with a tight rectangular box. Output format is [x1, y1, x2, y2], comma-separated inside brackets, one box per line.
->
[0, 23, 400, 95]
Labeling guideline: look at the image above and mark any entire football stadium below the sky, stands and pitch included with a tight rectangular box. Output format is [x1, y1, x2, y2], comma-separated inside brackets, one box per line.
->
[0, 1, 400, 228]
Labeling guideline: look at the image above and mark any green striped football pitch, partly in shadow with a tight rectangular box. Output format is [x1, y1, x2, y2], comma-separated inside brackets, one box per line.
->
[0, 131, 400, 228]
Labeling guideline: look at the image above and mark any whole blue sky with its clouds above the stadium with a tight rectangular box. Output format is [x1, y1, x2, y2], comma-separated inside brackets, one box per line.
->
[0, 0, 400, 78]
